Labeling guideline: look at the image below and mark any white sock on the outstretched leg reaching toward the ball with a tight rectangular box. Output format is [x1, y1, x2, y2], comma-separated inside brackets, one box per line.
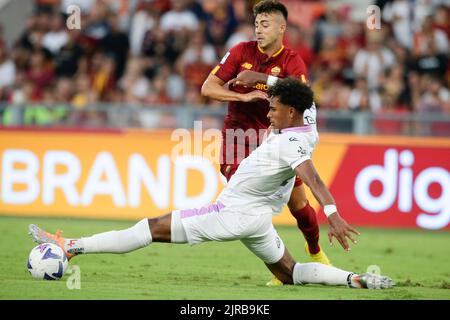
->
[65, 219, 152, 254]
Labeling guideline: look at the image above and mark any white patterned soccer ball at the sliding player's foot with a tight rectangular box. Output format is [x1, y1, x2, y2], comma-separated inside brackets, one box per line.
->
[28, 243, 69, 280]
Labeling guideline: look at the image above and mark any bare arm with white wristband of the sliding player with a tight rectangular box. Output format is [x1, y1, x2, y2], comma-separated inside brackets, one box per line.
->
[295, 160, 359, 250]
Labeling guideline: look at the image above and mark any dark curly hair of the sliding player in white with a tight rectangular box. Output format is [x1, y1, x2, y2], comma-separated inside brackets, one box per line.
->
[267, 78, 314, 114]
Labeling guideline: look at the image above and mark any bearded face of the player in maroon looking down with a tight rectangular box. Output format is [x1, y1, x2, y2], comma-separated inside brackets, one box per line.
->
[255, 13, 286, 50]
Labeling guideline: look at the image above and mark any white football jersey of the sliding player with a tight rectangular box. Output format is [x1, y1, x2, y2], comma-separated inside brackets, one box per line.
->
[217, 125, 316, 215]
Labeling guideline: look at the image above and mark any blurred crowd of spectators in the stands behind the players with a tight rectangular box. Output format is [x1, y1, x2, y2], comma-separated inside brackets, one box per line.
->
[0, 0, 450, 130]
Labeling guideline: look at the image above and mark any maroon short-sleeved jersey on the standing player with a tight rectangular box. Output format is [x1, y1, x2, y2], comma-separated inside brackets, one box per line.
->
[211, 41, 307, 132]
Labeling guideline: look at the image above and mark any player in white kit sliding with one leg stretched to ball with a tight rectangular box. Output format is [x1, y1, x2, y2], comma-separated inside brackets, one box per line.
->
[29, 78, 393, 289]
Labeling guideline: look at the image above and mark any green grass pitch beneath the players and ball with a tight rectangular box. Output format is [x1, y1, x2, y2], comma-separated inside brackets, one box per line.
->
[0, 216, 450, 300]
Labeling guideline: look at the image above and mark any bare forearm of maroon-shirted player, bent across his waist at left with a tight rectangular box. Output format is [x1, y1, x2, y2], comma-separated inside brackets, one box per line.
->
[201, 73, 267, 102]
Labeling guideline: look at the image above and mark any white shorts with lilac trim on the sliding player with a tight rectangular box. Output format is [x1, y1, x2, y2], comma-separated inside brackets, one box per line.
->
[172, 202, 284, 264]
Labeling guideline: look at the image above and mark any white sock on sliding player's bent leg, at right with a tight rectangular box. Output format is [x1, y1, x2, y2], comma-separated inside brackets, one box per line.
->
[292, 262, 353, 286]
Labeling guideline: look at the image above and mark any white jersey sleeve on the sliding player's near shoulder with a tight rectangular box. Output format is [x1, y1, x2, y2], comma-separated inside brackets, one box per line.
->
[280, 134, 311, 170]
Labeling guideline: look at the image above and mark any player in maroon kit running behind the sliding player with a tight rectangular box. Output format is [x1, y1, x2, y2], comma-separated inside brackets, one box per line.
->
[202, 0, 331, 285]
